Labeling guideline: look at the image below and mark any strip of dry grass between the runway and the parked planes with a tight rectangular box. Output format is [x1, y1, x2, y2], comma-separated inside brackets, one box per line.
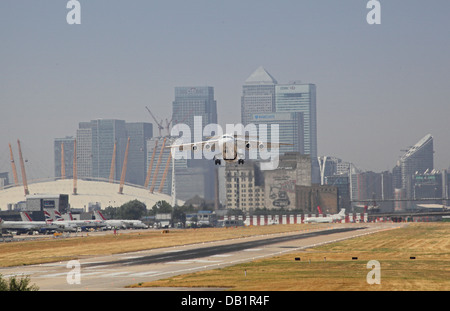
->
[0, 225, 308, 267]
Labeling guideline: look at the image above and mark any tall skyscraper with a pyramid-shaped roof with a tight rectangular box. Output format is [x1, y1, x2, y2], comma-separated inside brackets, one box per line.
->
[241, 67, 278, 126]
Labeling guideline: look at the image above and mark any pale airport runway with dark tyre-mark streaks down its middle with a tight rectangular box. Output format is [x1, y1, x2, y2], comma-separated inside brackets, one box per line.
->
[0, 224, 398, 291]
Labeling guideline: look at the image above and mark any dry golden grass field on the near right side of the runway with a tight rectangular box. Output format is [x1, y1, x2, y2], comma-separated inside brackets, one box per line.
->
[130, 223, 450, 291]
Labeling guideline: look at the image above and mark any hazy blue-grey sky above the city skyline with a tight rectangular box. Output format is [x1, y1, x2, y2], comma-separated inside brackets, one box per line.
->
[0, 0, 450, 178]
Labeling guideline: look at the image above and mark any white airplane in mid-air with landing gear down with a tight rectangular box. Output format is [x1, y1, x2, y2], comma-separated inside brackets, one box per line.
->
[166, 134, 292, 165]
